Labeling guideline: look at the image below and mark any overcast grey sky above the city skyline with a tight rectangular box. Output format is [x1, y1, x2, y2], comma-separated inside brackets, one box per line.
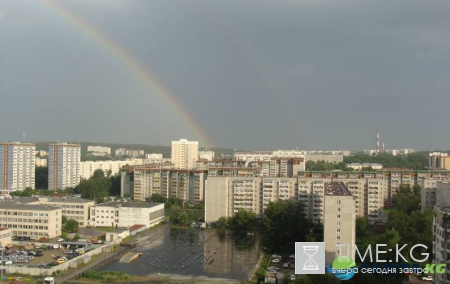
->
[0, 0, 450, 150]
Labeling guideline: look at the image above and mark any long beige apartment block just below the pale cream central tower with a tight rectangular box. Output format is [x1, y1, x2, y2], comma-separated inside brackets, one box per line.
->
[131, 165, 207, 203]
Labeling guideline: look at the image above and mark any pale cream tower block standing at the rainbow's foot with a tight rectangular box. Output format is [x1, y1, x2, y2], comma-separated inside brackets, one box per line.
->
[171, 139, 198, 169]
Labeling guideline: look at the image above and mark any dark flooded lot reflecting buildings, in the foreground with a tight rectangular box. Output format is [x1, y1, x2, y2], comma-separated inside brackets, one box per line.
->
[102, 227, 260, 280]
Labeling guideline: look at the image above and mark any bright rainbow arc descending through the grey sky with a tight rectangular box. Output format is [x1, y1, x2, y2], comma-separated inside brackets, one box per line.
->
[41, 0, 213, 148]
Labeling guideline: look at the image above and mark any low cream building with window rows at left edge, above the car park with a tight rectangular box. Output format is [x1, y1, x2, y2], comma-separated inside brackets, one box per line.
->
[0, 202, 62, 238]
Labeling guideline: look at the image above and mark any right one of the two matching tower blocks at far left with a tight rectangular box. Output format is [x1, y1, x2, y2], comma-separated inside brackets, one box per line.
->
[48, 142, 81, 190]
